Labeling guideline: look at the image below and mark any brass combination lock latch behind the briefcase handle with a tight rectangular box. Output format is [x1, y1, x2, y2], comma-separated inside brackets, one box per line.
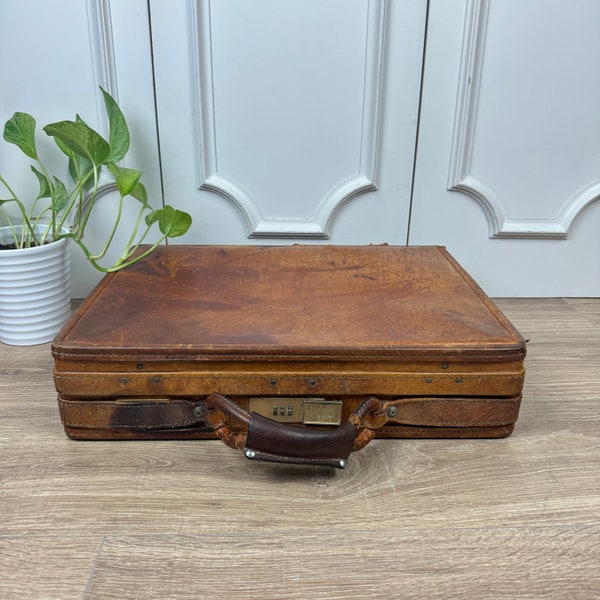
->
[248, 396, 342, 425]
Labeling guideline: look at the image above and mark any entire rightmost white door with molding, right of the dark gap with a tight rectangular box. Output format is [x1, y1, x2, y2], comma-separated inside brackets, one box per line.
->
[409, 0, 600, 296]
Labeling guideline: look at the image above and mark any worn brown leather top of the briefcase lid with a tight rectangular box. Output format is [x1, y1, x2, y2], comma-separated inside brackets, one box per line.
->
[53, 245, 525, 361]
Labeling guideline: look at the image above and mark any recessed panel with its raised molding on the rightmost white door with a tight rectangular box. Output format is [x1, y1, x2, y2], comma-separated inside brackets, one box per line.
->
[449, 0, 600, 238]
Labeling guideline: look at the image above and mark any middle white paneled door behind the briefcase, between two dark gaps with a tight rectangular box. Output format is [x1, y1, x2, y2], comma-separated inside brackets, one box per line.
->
[150, 0, 426, 244]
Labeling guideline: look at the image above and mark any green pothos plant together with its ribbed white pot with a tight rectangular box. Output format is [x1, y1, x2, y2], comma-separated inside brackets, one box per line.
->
[0, 88, 192, 345]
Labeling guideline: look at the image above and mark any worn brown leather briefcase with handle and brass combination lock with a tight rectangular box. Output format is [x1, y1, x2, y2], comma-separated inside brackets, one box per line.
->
[52, 245, 526, 467]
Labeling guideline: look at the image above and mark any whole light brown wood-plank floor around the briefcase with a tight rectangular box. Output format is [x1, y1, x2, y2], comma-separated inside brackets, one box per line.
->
[0, 299, 600, 600]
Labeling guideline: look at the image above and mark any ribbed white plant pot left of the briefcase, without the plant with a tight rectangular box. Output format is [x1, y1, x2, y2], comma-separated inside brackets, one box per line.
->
[0, 227, 71, 346]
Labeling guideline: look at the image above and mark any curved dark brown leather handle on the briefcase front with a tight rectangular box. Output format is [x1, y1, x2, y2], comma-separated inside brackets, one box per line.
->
[202, 394, 386, 469]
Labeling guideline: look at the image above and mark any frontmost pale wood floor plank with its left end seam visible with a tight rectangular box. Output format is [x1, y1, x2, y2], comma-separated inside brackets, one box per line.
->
[86, 528, 600, 600]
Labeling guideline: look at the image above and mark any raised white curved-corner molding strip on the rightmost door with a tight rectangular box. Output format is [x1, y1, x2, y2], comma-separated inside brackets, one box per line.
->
[448, 0, 600, 239]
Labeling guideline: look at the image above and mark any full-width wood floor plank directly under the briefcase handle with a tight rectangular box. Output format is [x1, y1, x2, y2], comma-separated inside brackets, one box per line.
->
[1, 424, 600, 535]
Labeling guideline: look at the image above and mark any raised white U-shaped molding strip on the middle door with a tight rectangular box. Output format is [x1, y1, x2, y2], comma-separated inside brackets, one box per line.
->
[191, 0, 389, 239]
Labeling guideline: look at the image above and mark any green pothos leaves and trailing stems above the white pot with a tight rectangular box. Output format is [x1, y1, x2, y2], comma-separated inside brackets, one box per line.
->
[0, 88, 192, 272]
